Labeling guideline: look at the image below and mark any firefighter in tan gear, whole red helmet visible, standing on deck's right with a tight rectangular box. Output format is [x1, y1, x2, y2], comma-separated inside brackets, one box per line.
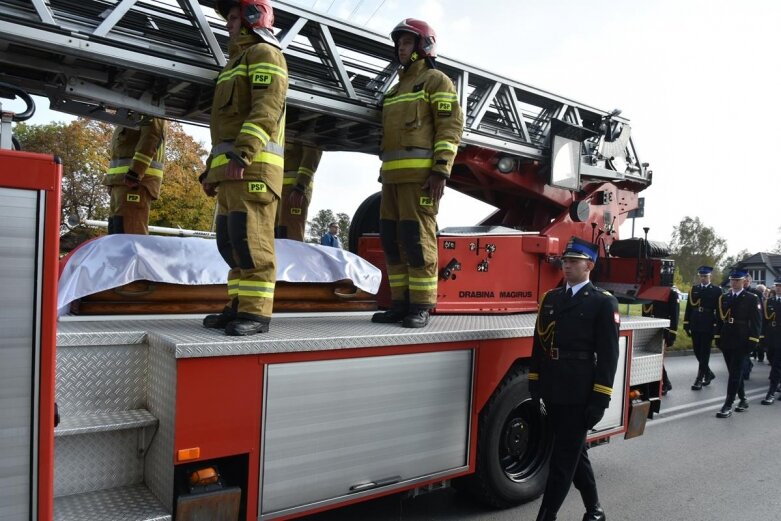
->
[372, 18, 464, 327]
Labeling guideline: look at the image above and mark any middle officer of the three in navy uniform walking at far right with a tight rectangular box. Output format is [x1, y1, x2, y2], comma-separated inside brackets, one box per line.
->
[715, 270, 762, 418]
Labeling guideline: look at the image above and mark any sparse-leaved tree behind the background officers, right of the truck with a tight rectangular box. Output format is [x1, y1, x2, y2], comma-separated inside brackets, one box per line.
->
[670, 216, 727, 281]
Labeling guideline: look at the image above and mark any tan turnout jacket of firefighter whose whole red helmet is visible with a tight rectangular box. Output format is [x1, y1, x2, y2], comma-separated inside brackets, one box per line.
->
[380, 60, 464, 184]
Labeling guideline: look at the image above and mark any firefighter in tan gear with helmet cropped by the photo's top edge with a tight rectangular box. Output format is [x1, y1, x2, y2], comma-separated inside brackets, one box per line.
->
[200, 0, 288, 336]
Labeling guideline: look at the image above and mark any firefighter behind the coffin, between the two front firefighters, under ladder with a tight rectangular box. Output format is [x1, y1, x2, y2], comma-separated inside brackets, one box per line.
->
[275, 143, 323, 242]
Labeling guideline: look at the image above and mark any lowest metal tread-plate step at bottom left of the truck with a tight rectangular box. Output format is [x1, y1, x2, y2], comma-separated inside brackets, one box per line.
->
[54, 485, 171, 521]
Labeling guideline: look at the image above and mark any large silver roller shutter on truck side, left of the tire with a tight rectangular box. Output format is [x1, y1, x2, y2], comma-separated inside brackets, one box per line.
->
[260, 350, 472, 519]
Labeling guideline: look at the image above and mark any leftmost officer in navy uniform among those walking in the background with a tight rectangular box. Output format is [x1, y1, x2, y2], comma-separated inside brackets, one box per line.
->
[683, 266, 721, 391]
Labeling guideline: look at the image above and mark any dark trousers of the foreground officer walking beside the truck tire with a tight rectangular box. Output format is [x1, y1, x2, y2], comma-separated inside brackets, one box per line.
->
[541, 404, 599, 513]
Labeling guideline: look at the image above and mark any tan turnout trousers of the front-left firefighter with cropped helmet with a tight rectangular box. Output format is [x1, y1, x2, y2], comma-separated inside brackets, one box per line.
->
[216, 180, 279, 318]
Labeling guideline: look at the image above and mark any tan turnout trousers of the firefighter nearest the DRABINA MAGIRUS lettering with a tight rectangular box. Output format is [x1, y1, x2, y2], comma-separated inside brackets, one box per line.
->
[380, 183, 439, 308]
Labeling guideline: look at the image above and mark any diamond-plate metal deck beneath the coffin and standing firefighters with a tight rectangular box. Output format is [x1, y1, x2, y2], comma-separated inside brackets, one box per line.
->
[57, 313, 668, 358]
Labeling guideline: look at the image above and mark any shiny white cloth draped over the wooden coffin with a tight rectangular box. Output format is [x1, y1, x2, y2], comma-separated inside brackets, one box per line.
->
[57, 235, 382, 315]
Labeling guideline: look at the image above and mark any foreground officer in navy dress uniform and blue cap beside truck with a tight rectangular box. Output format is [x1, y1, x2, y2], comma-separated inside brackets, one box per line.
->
[529, 237, 619, 521]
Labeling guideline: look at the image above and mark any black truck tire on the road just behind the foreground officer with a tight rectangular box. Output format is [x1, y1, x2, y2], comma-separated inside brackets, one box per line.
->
[457, 369, 552, 508]
